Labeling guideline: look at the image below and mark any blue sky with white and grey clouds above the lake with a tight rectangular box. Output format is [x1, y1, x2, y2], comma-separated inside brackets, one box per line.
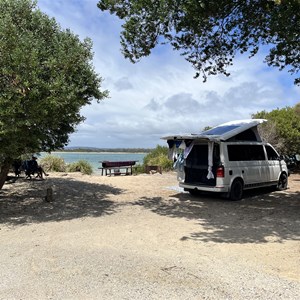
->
[37, 0, 300, 148]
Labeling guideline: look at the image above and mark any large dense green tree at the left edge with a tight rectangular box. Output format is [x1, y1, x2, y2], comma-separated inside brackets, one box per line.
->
[0, 0, 107, 188]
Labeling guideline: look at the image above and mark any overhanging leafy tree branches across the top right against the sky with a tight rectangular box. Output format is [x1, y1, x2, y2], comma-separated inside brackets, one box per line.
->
[98, 0, 300, 84]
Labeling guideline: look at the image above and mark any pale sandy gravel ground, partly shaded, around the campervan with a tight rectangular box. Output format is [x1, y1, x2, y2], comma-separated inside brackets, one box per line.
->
[0, 173, 300, 300]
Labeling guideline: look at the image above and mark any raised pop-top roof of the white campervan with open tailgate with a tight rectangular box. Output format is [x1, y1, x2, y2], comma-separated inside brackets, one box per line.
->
[162, 119, 267, 142]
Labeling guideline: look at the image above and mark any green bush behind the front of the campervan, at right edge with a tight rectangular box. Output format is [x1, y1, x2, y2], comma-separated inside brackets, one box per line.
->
[252, 105, 300, 154]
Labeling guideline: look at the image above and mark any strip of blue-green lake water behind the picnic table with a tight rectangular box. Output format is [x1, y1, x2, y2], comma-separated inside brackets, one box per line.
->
[40, 152, 147, 173]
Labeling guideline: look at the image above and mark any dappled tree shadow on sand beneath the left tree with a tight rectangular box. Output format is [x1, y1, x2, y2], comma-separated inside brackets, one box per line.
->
[0, 177, 122, 225]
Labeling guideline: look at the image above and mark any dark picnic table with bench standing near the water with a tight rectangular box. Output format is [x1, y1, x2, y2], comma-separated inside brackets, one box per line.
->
[98, 160, 138, 176]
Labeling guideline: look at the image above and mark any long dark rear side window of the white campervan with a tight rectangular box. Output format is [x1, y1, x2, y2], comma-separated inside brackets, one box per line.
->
[227, 145, 266, 161]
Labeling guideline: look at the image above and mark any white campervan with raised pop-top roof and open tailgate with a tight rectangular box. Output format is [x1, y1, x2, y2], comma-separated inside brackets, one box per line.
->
[163, 119, 288, 200]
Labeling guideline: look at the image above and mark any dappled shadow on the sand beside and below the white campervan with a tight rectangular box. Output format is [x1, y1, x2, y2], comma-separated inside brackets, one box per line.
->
[134, 183, 300, 243]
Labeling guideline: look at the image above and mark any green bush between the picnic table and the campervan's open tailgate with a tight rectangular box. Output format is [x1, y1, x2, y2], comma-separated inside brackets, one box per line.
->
[144, 145, 173, 171]
